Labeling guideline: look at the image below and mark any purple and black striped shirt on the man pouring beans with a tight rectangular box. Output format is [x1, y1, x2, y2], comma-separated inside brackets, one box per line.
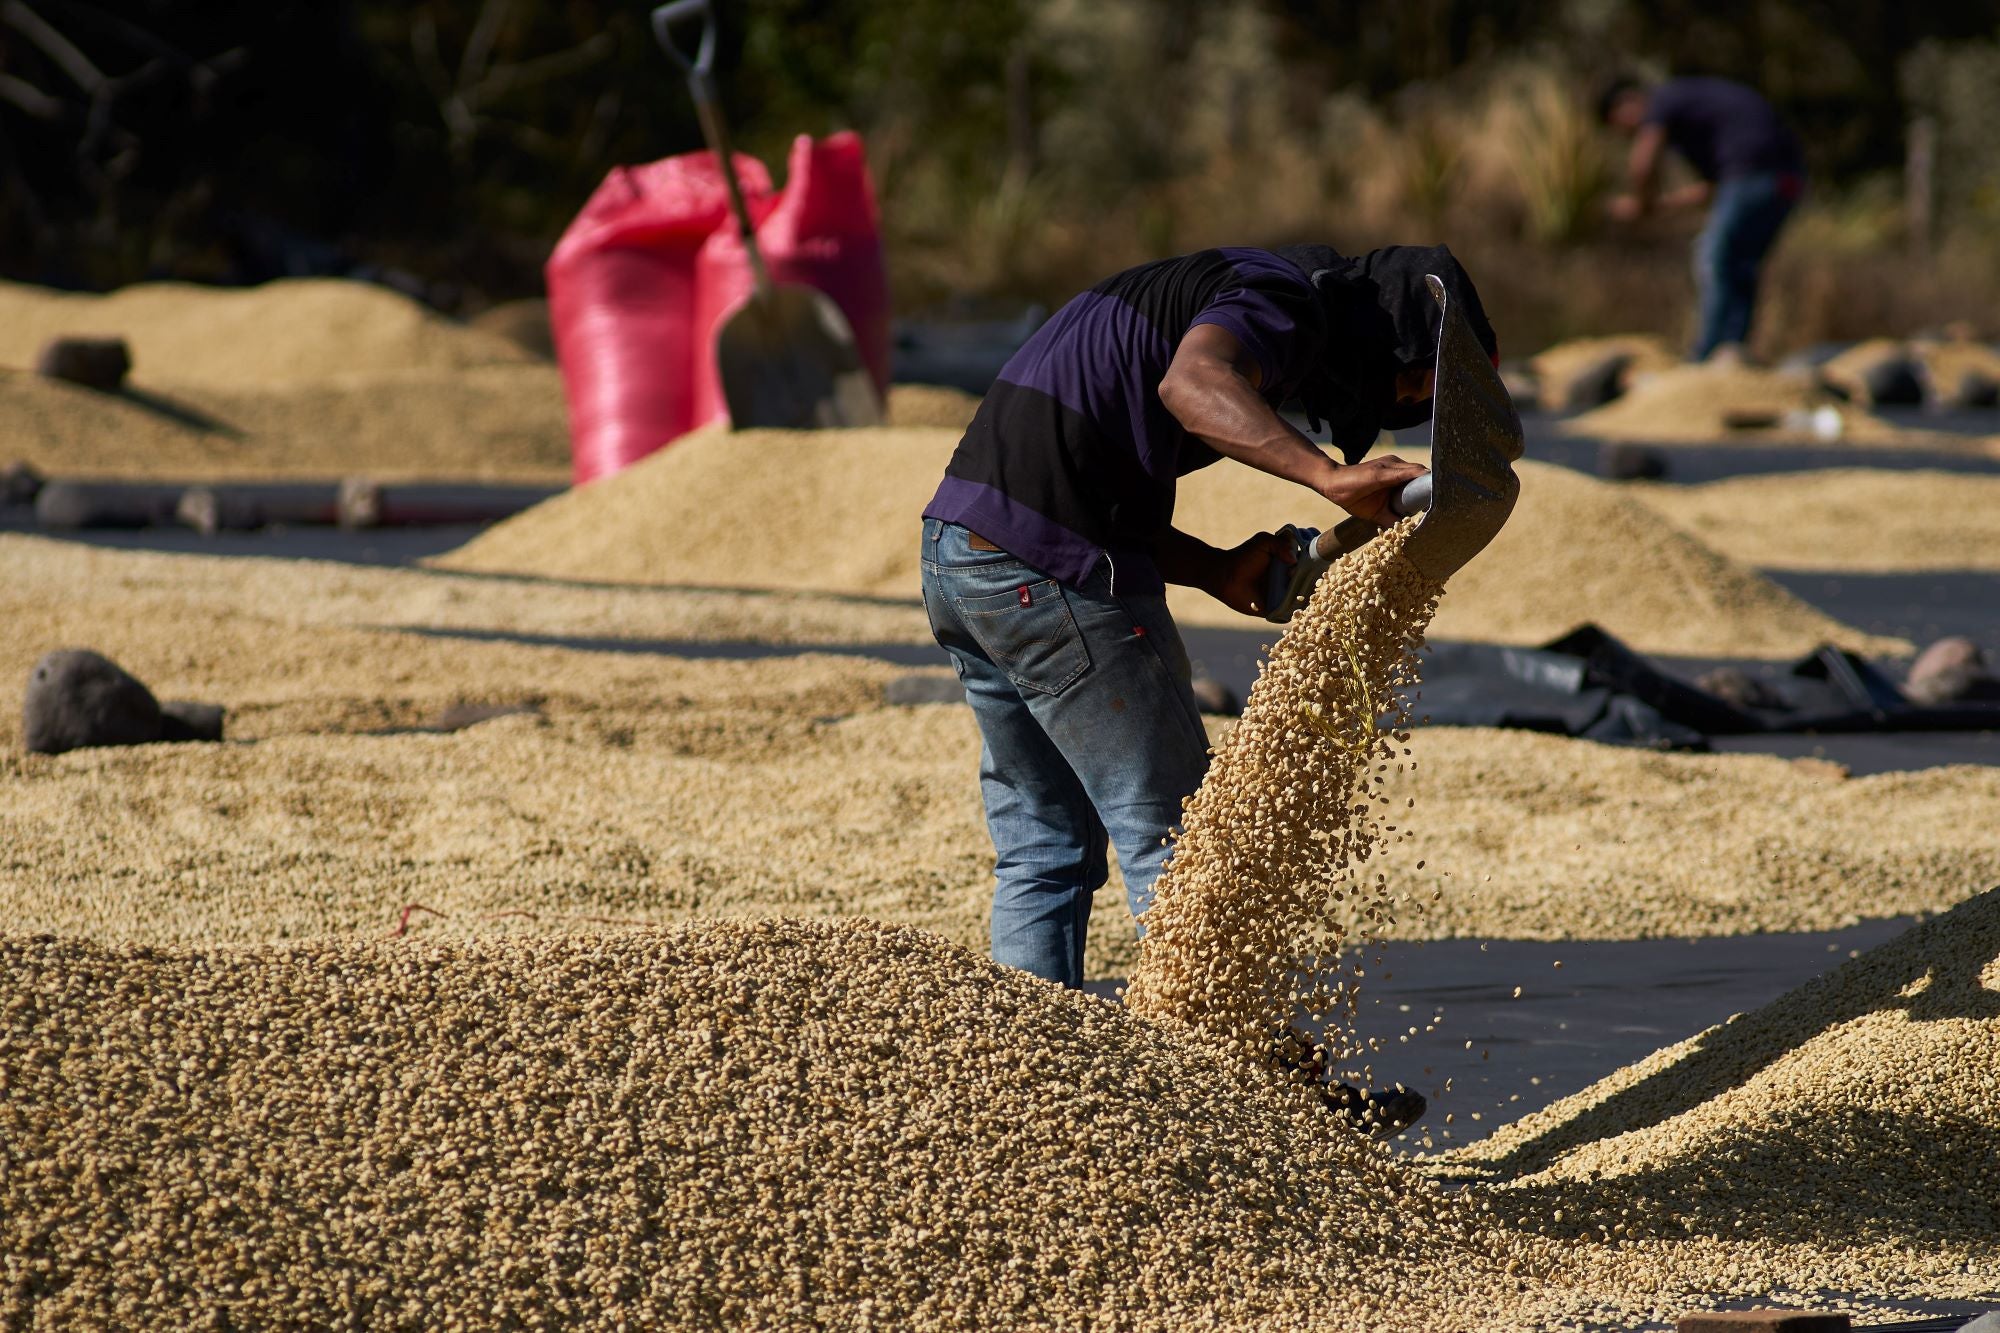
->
[924, 248, 1326, 592]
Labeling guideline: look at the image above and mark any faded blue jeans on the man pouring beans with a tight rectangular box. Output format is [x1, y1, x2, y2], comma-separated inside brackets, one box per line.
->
[922, 518, 1208, 987]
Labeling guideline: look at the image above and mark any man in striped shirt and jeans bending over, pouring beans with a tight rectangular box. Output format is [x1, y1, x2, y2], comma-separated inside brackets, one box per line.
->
[922, 246, 1496, 987]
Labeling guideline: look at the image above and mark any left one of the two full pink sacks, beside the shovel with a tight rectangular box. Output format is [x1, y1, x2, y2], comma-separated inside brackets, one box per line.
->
[544, 152, 770, 484]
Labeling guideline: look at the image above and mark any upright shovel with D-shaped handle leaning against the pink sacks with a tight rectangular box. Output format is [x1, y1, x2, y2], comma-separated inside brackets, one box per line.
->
[652, 0, 882, 430]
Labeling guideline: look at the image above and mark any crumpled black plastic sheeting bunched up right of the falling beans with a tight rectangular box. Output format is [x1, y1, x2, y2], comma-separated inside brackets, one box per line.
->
[1418, 624, 2000, 751]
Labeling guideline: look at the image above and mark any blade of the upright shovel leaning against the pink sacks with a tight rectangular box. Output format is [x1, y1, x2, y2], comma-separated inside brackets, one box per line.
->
[716, 282, 882, 430]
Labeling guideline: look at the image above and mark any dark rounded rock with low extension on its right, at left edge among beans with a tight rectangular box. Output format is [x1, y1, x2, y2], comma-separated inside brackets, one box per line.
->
[22, 648, 222, 755]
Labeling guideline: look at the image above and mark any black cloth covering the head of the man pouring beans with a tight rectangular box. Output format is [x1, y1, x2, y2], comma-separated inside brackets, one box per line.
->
[1278, 246, 1500, 464]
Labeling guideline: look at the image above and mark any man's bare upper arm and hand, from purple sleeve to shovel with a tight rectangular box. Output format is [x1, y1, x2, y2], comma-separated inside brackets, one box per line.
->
[1160, 324, 1424, 522]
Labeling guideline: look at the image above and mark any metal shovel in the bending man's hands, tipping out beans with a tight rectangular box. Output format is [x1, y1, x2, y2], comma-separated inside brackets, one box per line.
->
[1264, 274, 1522, 624]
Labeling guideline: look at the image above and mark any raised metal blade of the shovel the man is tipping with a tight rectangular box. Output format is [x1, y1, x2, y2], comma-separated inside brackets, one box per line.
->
[1402, 278, 1522, 582]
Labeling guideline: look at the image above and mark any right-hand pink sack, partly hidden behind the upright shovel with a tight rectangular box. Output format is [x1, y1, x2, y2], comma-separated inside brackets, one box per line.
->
[694, 130, 888, 426]
